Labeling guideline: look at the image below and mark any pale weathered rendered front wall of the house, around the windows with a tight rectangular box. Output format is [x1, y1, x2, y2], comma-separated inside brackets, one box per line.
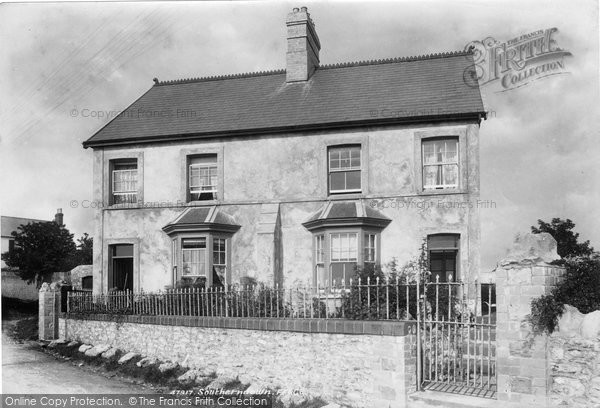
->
[94, 123, 480, 292]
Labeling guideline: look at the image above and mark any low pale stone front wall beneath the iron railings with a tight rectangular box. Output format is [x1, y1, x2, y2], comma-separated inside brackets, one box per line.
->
[60, 316, 416, 407]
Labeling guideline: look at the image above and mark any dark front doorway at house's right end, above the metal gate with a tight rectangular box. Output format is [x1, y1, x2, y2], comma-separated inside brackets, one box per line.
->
[427, 234, 460, 282]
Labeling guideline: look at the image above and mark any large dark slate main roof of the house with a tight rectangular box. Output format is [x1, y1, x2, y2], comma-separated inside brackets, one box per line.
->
[83, 52, 485, 147]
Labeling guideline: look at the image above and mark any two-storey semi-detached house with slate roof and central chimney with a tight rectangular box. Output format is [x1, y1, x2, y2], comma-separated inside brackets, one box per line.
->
[83, 7, 486, 293]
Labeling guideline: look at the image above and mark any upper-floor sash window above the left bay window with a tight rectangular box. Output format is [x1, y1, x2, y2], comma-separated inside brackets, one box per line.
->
[188, 154, 219, 201]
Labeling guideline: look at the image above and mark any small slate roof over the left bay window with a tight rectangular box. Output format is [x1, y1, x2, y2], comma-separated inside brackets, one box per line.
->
[163, 205, 240, 234]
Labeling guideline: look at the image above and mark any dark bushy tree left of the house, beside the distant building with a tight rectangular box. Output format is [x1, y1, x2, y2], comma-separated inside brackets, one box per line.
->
[2, 222, 76, 288]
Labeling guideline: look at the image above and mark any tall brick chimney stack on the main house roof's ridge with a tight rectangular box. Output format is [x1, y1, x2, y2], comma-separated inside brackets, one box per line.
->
[286, 7, 321, 82]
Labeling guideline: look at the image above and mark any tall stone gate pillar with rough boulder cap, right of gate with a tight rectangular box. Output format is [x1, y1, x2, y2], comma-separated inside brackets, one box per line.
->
[495, 233, 564, 407]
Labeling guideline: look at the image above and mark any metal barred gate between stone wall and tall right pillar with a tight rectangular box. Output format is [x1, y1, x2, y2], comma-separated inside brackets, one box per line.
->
[417, 279, 497, 398]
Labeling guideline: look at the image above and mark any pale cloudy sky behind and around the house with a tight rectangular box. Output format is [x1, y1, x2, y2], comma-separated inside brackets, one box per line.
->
[0, 0, 600, 270]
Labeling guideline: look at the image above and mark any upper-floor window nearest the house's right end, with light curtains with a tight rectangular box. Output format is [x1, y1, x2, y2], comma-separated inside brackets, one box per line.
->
[422, 137, 458, 189]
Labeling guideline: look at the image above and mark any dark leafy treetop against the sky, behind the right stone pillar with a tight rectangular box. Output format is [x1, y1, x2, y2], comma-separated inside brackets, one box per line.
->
[531, 218, 594, 258]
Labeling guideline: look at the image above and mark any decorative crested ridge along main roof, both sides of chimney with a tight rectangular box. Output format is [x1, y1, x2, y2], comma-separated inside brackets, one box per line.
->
[154, 51, 473, 86]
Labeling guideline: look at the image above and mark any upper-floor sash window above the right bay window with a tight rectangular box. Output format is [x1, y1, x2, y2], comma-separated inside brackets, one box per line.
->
[328, 146, 362, 194]
